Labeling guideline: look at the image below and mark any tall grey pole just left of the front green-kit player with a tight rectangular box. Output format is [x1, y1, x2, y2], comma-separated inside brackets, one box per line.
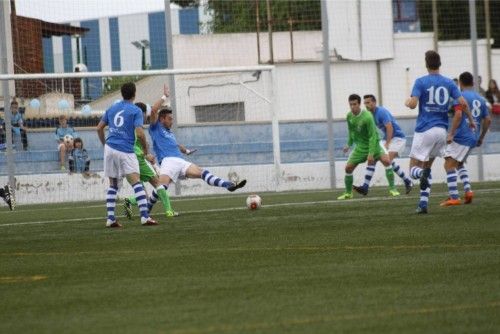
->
[321, 0, 337, 189]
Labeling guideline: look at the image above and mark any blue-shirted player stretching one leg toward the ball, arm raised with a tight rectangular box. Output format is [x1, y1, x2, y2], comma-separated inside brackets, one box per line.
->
[149, 88, 246, 200]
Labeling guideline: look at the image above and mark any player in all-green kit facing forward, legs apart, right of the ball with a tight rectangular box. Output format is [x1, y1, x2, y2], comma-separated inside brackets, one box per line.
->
[337, 94, 399, 200]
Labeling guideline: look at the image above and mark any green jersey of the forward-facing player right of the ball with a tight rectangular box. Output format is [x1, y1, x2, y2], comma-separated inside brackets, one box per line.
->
[347, 110, 380, 155]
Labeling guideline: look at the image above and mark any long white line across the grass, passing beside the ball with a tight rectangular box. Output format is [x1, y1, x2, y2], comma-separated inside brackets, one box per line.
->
[0, 189, 500, 227]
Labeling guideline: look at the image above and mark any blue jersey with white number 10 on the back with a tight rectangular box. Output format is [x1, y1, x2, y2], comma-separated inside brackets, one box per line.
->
[411, 74, 462, 132]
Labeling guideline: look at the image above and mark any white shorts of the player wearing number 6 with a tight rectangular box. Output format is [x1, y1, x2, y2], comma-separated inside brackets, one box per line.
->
[104, 145, 139, 179]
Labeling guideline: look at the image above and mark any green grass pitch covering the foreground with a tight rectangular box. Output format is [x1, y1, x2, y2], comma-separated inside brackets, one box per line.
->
[0, 182, 500, 334]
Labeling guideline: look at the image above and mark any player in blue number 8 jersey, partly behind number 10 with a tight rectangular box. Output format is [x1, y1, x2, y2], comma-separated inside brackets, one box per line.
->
[457, 72, 491, 204]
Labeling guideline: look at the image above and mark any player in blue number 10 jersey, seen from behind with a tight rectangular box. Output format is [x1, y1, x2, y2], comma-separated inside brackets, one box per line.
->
[405, 51, 473, 214]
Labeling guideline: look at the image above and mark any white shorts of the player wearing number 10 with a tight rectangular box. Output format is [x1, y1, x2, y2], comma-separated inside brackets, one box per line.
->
[410, 127, 447, 161]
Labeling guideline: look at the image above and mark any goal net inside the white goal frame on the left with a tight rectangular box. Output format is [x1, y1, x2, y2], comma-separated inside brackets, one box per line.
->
[0, 66, 279, 203]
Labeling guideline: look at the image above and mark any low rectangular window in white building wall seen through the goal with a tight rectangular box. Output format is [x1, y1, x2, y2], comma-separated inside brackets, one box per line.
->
[194, 102, 245, 123]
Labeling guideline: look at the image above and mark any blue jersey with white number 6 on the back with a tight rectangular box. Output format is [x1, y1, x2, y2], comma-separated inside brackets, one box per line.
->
[101, 101, 144, 153]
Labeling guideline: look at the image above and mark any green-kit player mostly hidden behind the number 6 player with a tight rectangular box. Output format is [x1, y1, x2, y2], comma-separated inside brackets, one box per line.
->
[123, 100, 178, 219]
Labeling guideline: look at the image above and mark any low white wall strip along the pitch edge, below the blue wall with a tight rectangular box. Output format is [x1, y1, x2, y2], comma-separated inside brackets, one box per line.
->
[0, 154, 500, 205]
